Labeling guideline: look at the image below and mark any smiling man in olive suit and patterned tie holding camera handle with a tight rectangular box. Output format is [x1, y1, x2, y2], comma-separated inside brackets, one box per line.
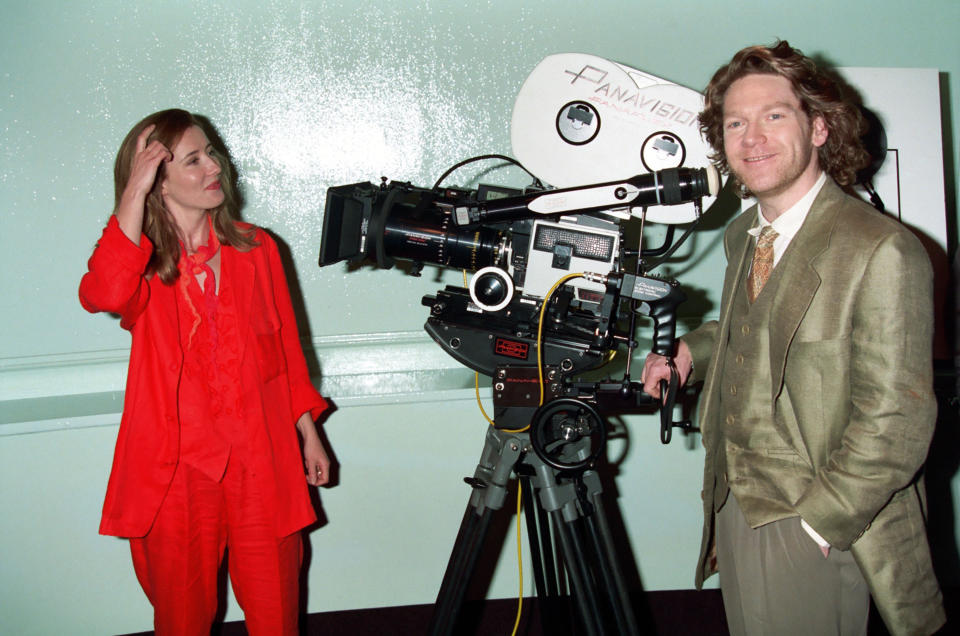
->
[643, 42, 945, 636]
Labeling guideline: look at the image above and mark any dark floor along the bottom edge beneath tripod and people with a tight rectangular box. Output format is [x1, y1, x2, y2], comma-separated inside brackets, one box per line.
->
[124, 589, 960, 636]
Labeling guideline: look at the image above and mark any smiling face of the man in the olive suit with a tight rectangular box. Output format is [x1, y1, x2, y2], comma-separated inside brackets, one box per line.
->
[723, 74, 827, 220]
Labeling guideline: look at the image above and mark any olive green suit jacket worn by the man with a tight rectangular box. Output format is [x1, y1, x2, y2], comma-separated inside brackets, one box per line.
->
[683, 179, 944, 634]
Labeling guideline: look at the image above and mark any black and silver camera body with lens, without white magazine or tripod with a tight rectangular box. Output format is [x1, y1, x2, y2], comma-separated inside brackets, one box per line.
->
[320, 170, 692, 426]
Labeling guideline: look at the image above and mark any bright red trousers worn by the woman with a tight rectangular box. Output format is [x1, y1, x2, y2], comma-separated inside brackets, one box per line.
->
[130, 458, 303, 636]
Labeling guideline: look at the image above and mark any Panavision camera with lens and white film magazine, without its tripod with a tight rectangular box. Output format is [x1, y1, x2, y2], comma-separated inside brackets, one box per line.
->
[319, 54, 719, 443]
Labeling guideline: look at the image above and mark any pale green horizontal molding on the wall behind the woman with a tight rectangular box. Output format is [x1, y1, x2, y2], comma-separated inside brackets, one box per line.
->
[0, 331, 490, 436]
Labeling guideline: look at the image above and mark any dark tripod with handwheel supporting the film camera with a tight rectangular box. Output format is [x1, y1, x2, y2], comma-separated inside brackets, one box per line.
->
[428, 399, 639, 636]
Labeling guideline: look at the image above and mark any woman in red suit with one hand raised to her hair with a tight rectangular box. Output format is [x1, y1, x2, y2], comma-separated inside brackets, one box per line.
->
[80, 110, 330, 636]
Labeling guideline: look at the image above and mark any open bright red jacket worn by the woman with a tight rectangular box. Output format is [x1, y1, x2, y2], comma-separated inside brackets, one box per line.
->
[80, 216, 327, 537]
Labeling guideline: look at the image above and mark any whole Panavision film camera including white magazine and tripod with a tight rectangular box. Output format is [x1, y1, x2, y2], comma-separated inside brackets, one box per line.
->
[319, 54, 720, 634]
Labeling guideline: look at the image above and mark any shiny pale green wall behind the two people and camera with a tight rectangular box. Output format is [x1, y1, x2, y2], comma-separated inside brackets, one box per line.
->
[0, 0, 960, 634]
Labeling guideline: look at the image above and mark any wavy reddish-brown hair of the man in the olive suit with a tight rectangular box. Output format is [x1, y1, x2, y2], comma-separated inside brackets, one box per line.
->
[699, 41, 870, 196]
